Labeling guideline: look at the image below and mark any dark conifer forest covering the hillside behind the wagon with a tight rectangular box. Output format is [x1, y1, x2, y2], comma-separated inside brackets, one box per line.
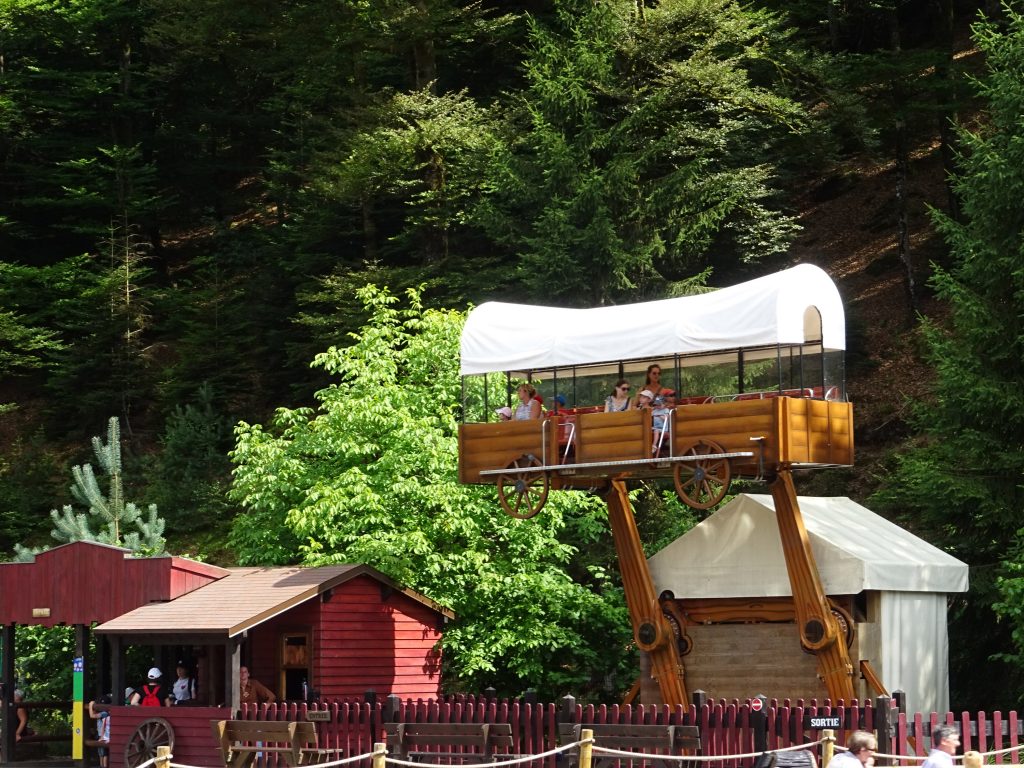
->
[0, 0, 1024, 709]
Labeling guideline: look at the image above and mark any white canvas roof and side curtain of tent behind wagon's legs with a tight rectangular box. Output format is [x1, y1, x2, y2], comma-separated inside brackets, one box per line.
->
[648, 494, 968, 712]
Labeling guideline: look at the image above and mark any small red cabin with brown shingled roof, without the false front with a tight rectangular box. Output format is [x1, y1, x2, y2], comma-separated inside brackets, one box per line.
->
[95, 565, 453, 710]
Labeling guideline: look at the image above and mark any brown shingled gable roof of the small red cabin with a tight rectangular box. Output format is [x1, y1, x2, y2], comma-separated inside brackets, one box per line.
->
[95, 565, 455, 638]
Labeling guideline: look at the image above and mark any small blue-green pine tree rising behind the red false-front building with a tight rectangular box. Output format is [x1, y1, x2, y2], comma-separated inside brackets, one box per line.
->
[14, 418, 165, 560]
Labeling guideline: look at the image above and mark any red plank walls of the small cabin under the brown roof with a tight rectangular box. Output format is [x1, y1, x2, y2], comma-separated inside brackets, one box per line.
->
[249, 577, 442, 698]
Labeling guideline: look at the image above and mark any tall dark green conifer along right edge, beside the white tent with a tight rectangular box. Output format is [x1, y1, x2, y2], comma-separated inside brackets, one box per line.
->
[873, 9, 1024, 709]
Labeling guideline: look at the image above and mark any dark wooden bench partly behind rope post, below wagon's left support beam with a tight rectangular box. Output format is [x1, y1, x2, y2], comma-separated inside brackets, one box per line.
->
[558, 723, 700, 768]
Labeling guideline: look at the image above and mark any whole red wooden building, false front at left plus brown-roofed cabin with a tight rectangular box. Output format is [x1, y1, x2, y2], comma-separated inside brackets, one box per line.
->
[0, 542, 453, 766]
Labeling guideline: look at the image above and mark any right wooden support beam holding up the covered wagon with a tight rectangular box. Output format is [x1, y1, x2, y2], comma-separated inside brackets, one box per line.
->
[771, 469, 855, 703]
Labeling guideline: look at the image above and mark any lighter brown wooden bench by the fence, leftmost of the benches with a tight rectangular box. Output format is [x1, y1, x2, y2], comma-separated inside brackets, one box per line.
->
[210, 720, 338, 768]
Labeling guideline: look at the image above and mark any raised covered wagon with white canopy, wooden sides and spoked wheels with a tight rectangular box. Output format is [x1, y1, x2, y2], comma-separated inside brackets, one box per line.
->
[459, 265, 854, 516]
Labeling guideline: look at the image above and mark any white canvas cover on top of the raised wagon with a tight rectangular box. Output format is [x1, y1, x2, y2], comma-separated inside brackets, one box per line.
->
[462, 264, 846, 376]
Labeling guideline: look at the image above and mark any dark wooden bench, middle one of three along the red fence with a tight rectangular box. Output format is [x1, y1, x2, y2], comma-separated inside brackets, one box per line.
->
[384, 723, 515, 765]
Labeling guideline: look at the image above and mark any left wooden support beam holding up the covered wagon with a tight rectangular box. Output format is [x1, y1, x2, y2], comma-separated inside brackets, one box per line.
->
[605, 480, 689, 707]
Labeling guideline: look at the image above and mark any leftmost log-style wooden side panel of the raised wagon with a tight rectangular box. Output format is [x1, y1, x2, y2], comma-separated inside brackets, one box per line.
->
[459, 419, 558, 482]
